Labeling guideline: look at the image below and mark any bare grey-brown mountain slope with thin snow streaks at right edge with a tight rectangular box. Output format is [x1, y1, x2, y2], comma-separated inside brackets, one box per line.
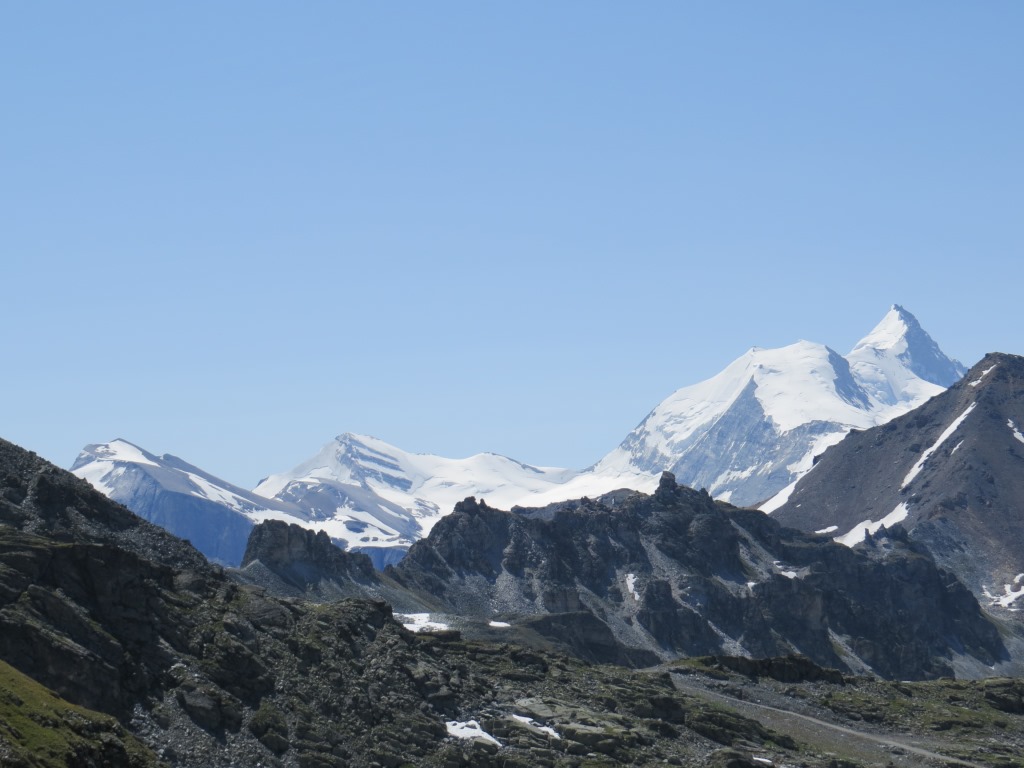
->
[772, 353, 1024, 604]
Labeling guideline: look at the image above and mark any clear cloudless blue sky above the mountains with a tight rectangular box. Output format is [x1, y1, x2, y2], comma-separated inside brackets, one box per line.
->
[0, 0, 1024, 486]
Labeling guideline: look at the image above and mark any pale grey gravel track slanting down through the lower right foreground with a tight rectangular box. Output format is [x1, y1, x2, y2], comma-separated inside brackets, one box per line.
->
[672, 675, 991, 768]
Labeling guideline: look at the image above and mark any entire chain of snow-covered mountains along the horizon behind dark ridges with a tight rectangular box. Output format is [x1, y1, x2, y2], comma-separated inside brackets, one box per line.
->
[72, 305, 965, 567]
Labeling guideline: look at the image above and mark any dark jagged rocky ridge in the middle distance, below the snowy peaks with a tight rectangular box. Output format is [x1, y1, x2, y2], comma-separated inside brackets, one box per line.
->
[388, 473, 1007, 678]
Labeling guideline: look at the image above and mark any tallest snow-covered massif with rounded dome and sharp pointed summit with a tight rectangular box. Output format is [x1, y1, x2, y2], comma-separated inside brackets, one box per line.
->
[590, 305, 965, 506]
